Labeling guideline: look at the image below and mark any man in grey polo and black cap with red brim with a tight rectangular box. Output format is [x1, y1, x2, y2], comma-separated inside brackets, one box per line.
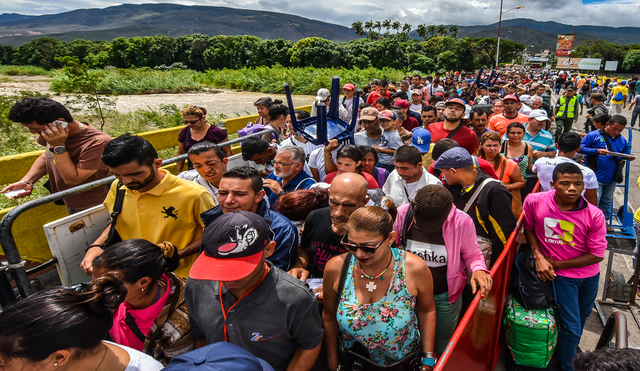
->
[184, 211, 324, 371]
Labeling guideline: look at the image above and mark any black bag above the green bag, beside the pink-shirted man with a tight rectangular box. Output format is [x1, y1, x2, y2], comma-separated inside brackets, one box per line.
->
[509, 244, 555, 310]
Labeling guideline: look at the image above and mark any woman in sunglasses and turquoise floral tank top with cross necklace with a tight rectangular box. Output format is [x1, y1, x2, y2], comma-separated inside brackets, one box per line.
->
[322, 197, 436, 370]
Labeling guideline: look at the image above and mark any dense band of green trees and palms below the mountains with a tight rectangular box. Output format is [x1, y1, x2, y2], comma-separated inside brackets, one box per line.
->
[0, 30, 525, 73]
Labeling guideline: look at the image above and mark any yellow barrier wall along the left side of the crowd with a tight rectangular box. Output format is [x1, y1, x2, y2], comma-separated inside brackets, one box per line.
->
[0, 106, 311, 262]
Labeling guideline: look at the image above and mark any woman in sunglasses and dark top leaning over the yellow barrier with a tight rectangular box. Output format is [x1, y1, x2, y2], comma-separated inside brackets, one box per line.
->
[176, 106, 233, 174]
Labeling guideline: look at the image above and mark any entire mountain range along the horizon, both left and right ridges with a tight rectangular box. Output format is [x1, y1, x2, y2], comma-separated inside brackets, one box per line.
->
[0, 4, 640, 52]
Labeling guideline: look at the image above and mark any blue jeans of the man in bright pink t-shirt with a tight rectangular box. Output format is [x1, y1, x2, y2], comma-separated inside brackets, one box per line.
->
[553, 273, 600, 371]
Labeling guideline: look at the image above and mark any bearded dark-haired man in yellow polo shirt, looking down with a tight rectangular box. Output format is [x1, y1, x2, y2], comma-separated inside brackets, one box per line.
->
[81, 134, 215, 278]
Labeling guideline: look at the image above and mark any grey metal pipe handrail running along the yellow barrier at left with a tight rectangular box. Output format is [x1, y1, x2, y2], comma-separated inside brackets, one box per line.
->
[0, 129, 280, 307]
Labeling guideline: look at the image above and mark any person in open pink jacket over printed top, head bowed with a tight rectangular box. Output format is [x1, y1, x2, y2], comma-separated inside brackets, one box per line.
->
[392, 185, 492, 355]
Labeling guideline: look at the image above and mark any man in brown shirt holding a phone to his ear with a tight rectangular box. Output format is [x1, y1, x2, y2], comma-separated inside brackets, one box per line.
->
[0, 97, 111, 214]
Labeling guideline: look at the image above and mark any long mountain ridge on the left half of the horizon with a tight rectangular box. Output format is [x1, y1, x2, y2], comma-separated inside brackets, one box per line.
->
[0, 4, 355, 46]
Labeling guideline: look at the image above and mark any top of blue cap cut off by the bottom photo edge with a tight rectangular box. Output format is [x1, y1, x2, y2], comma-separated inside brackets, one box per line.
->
[163, 341, 274, 371]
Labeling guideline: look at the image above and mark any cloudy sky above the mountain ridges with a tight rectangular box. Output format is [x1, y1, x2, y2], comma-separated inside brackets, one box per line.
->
[0, 0, 640, 27]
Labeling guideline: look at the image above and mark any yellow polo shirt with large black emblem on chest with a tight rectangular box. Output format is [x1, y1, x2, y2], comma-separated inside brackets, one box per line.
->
[104, 169, 215, 278]
